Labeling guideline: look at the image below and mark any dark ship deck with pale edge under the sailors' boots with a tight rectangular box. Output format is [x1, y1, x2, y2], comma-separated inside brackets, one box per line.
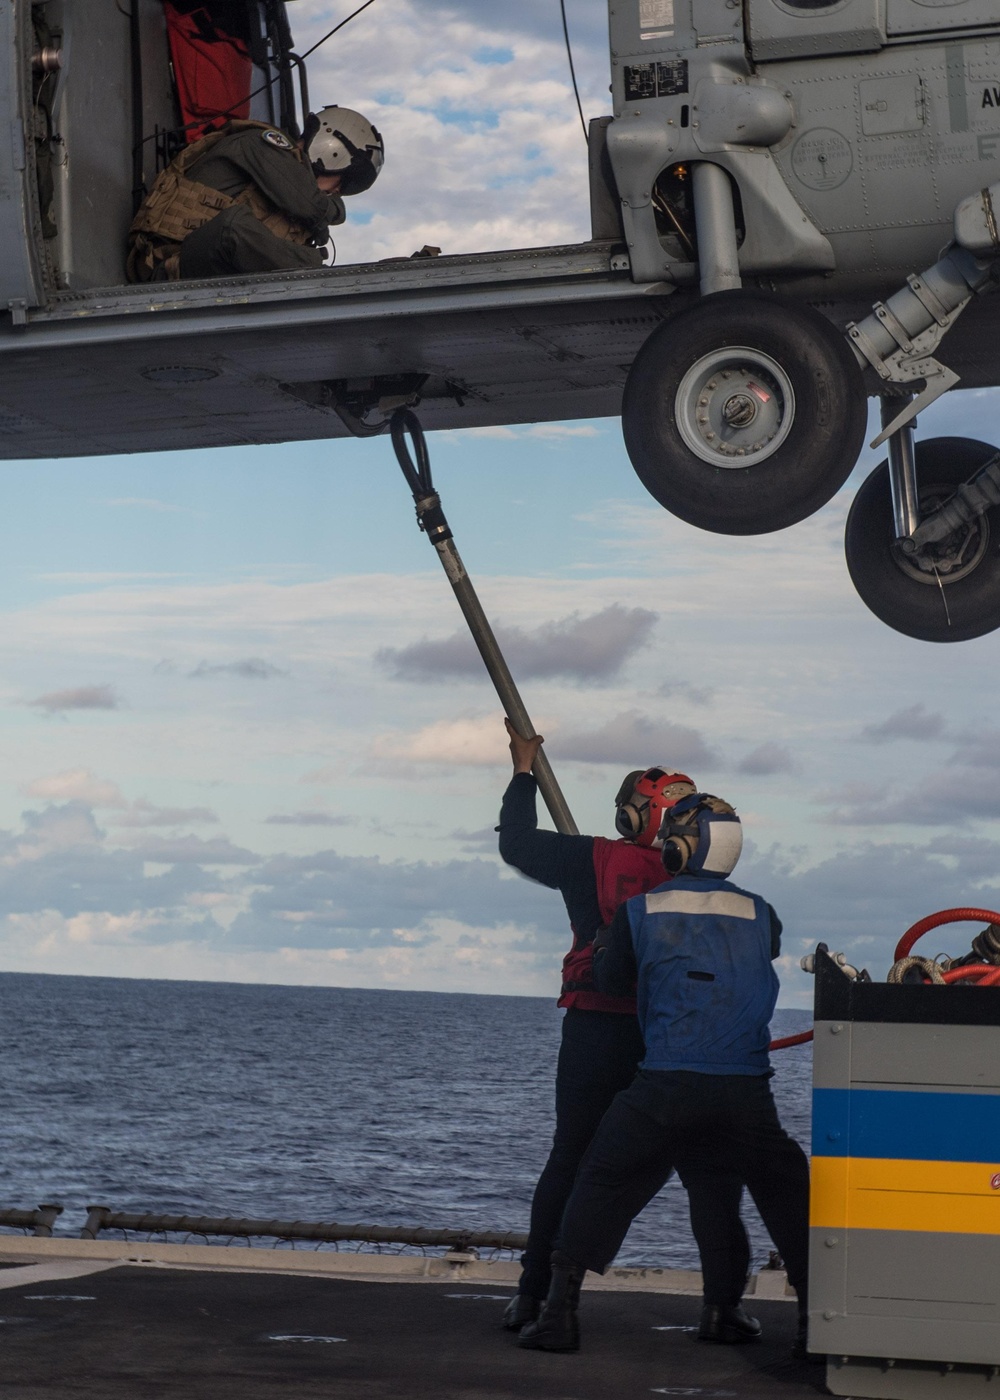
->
[0, 1238, 826, 1400]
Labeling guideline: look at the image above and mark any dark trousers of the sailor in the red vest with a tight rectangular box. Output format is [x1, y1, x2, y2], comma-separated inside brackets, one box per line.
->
[520, 1009, 749, 1305]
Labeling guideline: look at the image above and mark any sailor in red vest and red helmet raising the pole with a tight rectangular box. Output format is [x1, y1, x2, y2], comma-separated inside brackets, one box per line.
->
[499, 721, 759, 1341]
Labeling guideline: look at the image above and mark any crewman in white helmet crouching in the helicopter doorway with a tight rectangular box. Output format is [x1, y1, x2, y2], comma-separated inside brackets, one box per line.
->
[126, 106, 385, 281]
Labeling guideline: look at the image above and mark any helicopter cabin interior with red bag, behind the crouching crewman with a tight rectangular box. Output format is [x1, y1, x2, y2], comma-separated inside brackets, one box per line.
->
[22, 0, 299, 307]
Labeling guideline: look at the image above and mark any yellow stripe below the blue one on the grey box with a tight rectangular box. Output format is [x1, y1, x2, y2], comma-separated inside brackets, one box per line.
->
[810, 1156, 1000, 1235]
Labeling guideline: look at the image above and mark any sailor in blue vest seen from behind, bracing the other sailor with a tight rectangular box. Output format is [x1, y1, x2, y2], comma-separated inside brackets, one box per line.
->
[518, 792, 810, 1354]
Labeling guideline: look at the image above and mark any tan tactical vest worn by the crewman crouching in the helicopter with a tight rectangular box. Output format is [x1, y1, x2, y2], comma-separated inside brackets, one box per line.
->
[126, 122, 312, 281]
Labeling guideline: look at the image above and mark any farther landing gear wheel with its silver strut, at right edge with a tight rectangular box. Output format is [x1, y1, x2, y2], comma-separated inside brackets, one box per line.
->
[845, 428, 1000, 641]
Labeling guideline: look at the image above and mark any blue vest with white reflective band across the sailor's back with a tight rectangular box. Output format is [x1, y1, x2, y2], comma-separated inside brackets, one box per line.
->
[627, 875, 777, 1075]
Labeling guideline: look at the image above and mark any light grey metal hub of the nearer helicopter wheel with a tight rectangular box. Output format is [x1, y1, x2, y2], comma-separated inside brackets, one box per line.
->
[674, 346, 796, 468]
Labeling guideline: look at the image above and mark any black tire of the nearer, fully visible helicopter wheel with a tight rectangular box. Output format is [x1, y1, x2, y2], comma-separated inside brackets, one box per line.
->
[622, 291, 868, 535]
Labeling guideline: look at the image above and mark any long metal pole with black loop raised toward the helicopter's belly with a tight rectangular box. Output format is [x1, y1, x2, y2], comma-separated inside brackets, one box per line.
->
[391, 409, 580, 836]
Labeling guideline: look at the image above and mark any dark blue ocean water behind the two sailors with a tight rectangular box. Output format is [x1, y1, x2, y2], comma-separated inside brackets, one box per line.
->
[0, 973, 811, 1267]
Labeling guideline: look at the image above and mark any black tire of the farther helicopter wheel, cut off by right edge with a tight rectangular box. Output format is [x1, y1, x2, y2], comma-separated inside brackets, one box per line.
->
[845, 438, 1000, 641]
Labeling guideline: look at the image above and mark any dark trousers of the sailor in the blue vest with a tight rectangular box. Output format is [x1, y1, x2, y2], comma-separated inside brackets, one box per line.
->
[556, 1070, 810, 1306]
